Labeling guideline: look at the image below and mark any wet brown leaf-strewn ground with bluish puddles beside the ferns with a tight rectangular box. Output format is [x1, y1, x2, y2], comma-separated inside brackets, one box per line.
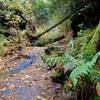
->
[0, 47, 66, 100]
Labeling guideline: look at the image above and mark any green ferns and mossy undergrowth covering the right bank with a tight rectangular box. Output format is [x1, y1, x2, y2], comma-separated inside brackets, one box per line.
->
[43, 24, 100, 99]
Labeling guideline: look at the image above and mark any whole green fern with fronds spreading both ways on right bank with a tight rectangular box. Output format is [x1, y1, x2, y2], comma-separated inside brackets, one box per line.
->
[44, 52, 100, 86]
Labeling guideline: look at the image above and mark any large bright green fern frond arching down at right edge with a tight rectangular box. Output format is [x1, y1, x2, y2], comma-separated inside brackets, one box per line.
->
[70, 52, 100, 86]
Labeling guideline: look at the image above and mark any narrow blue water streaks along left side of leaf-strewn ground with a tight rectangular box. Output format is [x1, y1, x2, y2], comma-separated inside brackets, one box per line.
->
[0, 53, 37, 94]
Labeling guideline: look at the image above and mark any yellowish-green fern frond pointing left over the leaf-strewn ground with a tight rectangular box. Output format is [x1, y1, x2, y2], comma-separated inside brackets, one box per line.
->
[42, 53, 79, 69]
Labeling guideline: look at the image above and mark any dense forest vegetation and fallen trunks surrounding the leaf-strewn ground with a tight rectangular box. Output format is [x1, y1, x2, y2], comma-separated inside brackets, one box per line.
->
[0, 0, 100, 100]
